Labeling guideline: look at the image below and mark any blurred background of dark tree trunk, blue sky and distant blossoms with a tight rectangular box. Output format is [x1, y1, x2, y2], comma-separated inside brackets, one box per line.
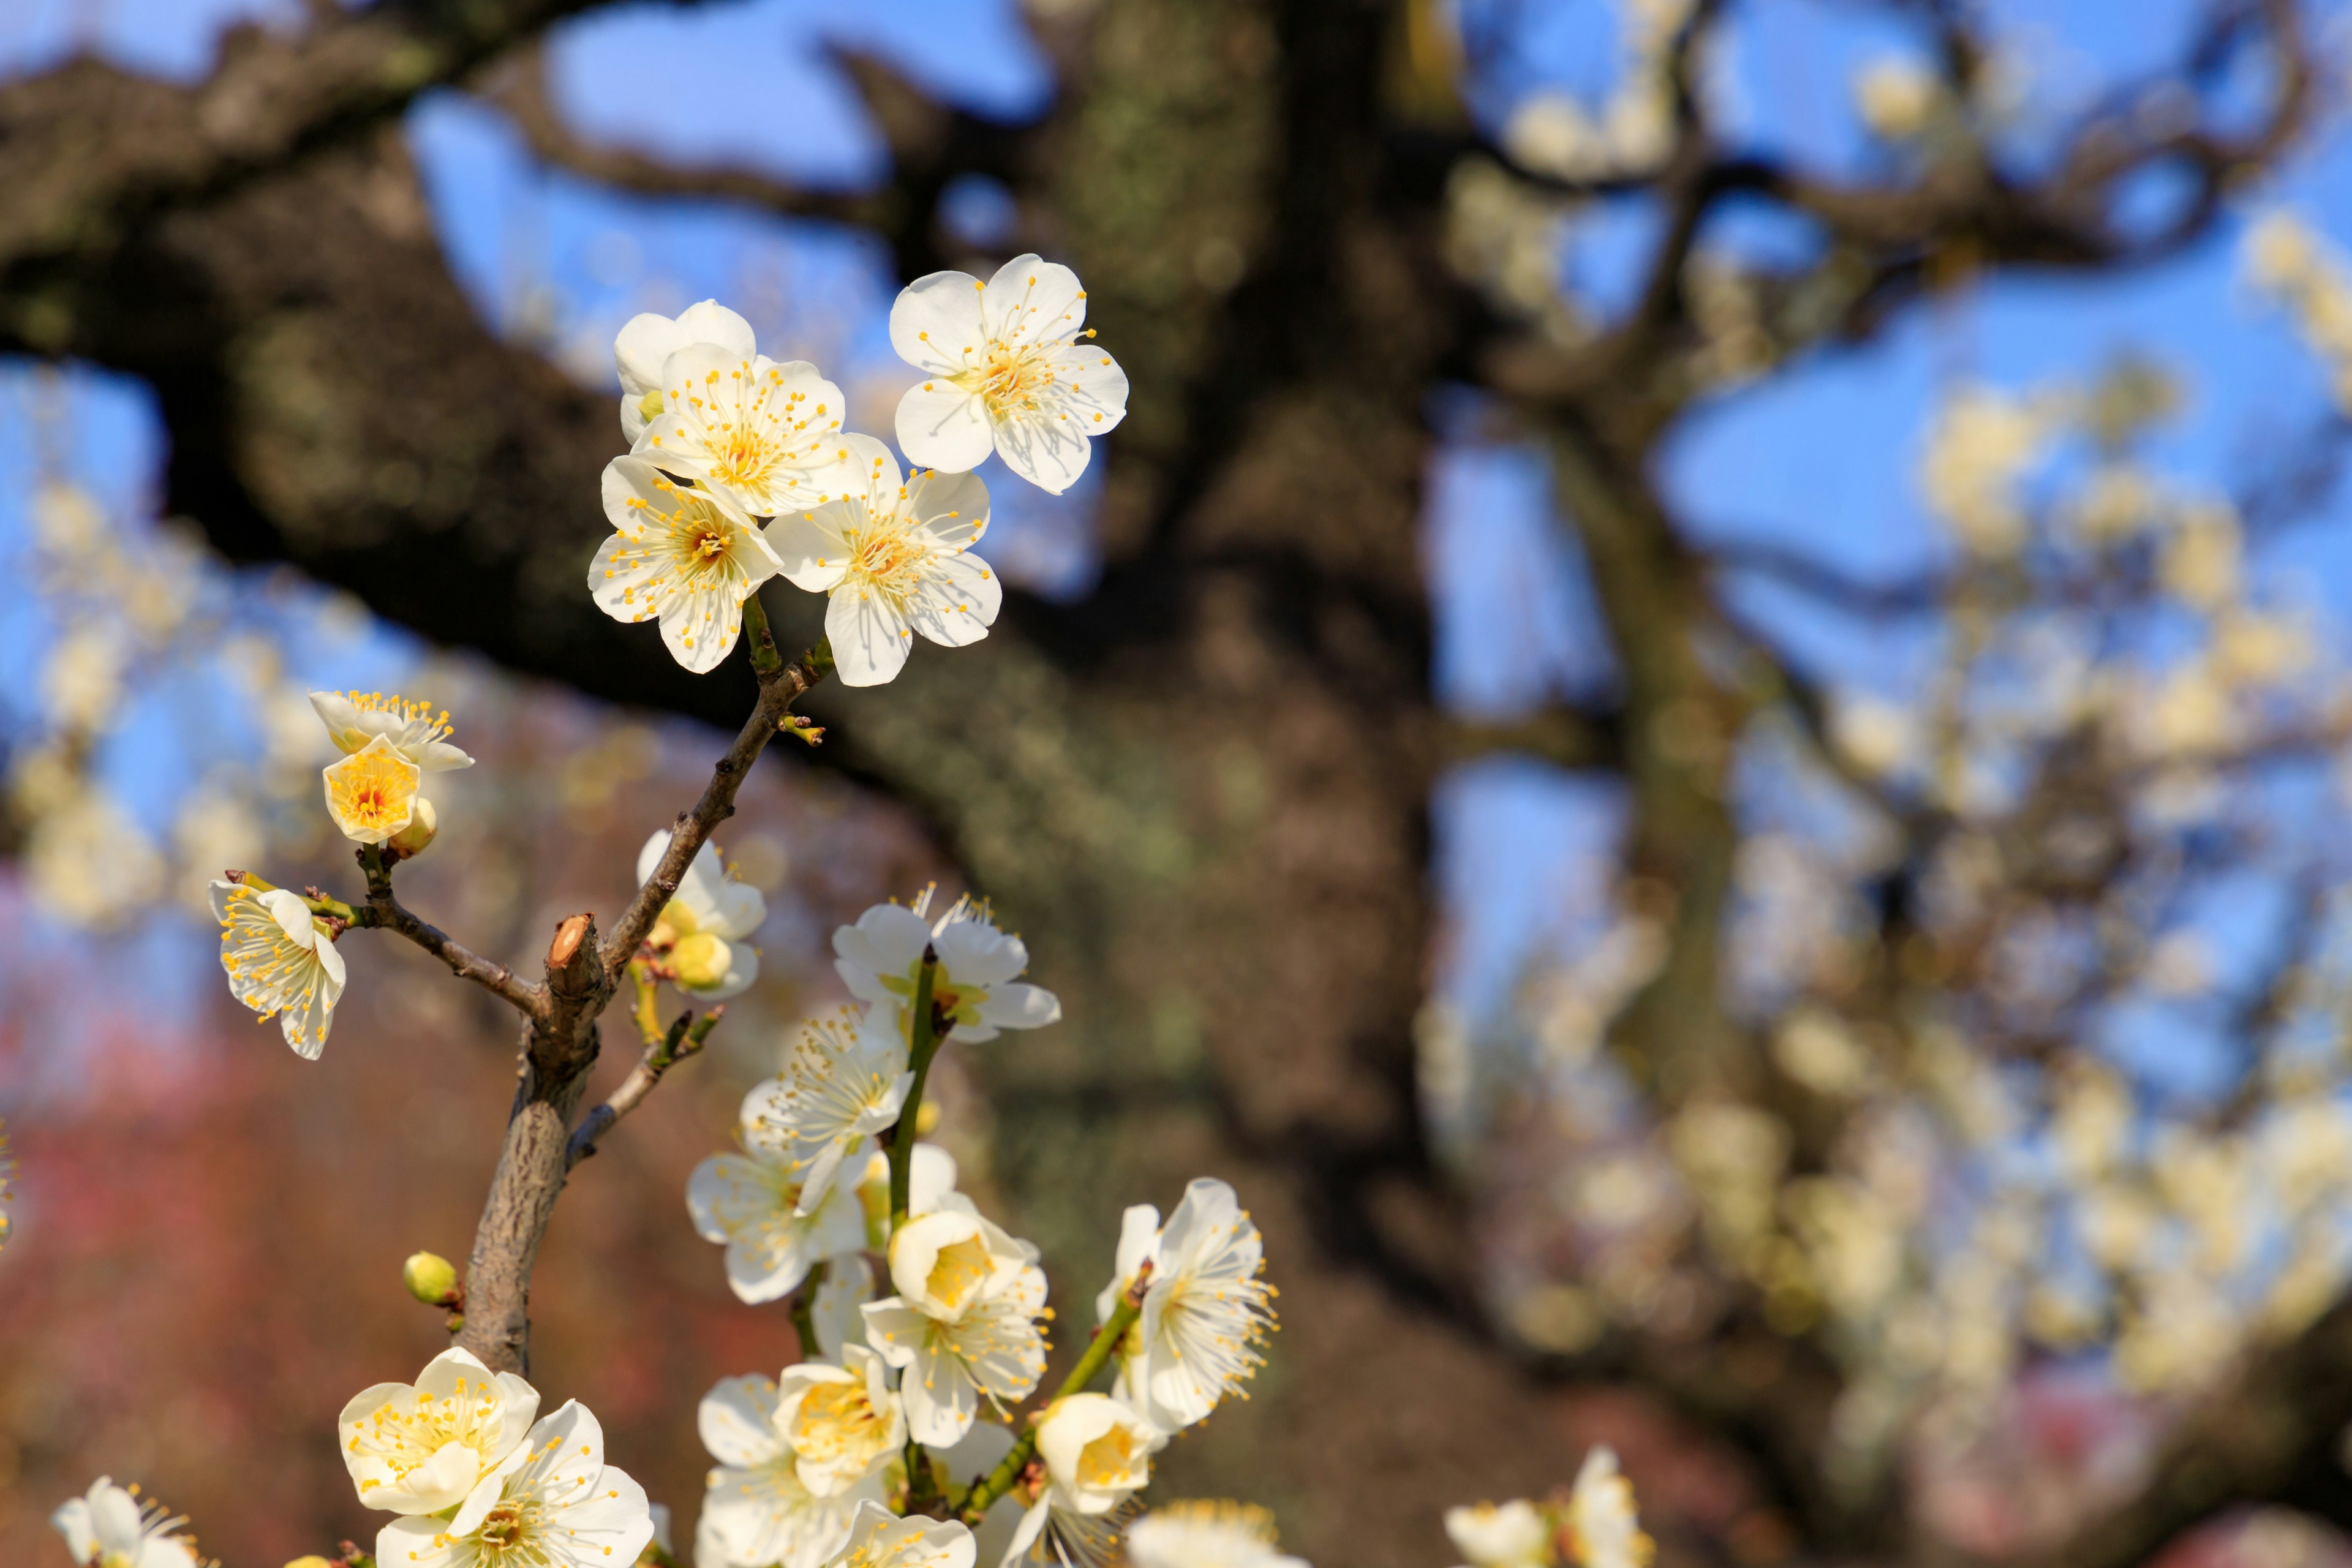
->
[0, 0, 2352, 1568]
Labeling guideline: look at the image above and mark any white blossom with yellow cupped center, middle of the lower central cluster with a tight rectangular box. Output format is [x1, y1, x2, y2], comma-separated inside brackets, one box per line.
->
[865, 1199, 1047, 1448]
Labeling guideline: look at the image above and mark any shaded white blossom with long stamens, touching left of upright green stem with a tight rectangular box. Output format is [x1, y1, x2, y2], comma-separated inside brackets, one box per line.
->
[743, 1009, 915, 1213]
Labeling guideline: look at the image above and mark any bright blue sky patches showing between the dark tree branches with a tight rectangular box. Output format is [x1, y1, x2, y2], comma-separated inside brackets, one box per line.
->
[0, 0, 2352, 1044]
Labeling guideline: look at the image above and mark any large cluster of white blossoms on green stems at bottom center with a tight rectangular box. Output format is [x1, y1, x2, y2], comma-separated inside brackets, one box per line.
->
[687, 889, 1291, 1568]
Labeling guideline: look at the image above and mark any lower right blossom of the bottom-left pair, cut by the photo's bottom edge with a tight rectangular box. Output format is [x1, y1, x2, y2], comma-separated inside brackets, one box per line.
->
[376, 1399, 654, 1568]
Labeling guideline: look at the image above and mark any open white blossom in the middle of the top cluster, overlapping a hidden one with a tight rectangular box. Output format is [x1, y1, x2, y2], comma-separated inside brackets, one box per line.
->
[630, 343, 851, 517]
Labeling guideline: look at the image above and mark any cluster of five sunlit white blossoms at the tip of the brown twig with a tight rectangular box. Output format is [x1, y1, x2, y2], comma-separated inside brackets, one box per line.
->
[588, 256, 1126, 687]
